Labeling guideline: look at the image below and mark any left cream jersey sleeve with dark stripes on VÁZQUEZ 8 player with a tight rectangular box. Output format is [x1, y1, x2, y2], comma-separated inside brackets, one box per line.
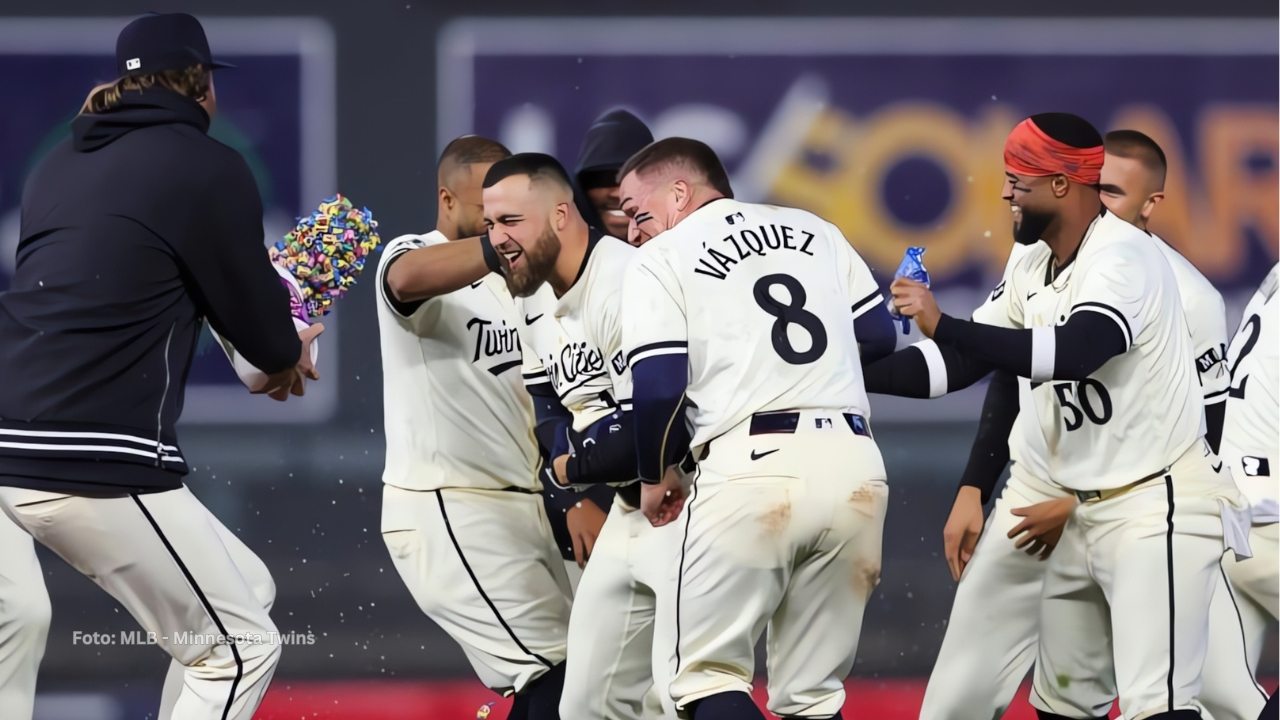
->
[621, 249, 689, 368]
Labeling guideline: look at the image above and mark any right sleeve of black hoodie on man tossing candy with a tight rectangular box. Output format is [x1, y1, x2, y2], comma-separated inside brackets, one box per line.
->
[180, 155, 302, 374]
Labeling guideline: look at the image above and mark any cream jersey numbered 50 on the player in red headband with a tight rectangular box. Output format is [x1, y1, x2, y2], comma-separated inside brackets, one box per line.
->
[974, 207, 1203, 491]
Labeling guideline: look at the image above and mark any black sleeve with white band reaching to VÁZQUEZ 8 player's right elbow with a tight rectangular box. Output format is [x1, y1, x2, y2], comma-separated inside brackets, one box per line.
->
[863, 341, 992, 398]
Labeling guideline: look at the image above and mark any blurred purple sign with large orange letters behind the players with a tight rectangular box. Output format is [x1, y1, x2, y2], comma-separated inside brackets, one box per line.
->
[438, 18, 1277, 302]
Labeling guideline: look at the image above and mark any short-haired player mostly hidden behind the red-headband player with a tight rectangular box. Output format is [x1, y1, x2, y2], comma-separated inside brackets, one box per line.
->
[920, 131, 1261, 720]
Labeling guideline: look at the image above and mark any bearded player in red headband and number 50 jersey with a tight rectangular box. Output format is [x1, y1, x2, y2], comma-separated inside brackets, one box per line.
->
[867, 113, 1248, 719]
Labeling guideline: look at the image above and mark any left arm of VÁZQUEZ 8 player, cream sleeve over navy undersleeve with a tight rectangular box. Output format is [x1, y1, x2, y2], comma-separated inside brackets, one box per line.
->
[622, 250, 689, 483]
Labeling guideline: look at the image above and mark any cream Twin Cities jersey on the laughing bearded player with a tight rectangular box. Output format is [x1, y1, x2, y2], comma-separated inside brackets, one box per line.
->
[516, 231, 636, 432]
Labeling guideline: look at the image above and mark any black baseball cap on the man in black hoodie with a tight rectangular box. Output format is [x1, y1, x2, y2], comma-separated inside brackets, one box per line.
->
[115, 13, 236, 77]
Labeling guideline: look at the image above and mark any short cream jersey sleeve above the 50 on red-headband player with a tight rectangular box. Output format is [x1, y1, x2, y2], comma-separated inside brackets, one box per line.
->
[1070, 246, 1152, 350]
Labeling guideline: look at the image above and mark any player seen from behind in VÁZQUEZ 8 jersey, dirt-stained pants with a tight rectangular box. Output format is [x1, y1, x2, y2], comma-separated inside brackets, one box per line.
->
[620, 137, 892, 720]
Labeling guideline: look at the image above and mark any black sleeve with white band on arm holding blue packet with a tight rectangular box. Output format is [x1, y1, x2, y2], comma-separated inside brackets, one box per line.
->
[933, 313, 1129, 380]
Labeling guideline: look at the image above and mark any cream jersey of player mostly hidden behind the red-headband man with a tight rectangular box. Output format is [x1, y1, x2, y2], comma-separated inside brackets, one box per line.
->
[973, 230, 1230, 480]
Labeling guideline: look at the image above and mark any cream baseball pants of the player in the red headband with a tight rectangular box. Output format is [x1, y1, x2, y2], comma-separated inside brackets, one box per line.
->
[1032, 443, 1247, 720]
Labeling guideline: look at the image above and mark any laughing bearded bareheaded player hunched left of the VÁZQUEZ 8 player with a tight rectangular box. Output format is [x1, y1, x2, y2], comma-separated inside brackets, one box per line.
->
[484, 152, 675, 720]
